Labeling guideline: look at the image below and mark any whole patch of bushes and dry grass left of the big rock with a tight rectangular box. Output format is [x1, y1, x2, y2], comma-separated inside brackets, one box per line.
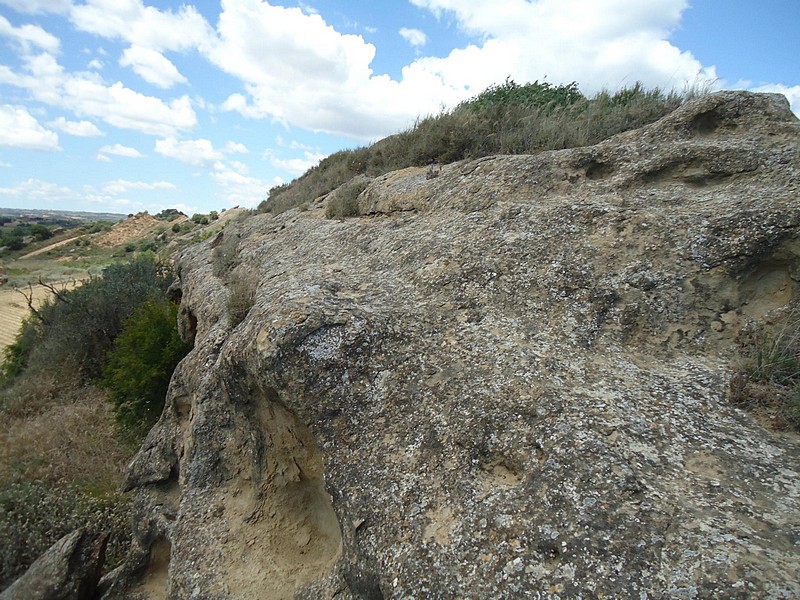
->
[0, 254, 189, 589]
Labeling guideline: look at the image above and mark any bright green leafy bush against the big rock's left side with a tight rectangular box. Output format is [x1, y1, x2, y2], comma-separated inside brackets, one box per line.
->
[101, 297, 191, 435]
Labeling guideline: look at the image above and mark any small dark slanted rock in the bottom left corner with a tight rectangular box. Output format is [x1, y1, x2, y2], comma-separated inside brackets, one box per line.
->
[0, 529, 108, 600]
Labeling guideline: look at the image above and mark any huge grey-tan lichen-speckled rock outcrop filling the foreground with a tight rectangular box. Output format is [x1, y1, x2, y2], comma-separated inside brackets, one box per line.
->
[107, 93, 800, 599]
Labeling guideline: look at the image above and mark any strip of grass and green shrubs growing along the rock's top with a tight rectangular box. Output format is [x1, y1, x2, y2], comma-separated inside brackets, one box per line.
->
[259, 79, 684, 216]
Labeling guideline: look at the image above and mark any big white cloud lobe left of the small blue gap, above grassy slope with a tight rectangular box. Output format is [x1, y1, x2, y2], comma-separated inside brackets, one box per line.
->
[205, 0, 450, 139]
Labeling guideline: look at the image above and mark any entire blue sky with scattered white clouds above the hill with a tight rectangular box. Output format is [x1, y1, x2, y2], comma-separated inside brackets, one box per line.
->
[0, 0, 800, 215]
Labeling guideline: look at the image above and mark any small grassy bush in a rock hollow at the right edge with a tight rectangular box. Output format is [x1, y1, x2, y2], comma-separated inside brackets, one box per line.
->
[729, 307, 800, 431]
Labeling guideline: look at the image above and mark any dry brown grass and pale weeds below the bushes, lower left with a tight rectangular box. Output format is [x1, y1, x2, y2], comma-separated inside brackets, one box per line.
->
[0, 372, 134, 589]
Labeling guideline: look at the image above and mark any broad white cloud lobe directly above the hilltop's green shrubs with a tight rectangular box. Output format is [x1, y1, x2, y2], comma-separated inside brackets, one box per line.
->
[410, 0, 716, 93]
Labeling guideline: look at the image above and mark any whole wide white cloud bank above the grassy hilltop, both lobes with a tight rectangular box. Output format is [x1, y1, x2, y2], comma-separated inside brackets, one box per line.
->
[205, 0, 716, 140]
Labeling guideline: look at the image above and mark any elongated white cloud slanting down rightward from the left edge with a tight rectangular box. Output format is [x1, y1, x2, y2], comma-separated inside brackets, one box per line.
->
[0, 54, 197, 136]
